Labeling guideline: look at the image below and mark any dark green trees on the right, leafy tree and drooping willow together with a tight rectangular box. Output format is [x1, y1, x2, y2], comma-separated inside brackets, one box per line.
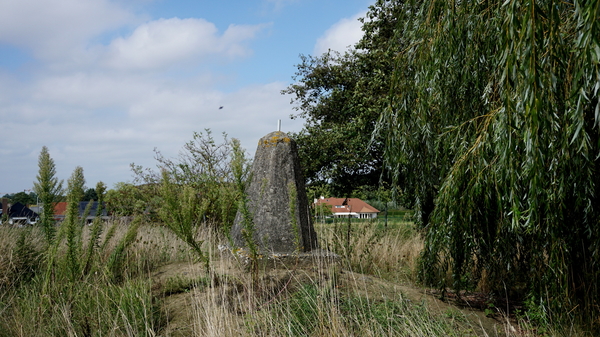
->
[284, 0, 600, 329]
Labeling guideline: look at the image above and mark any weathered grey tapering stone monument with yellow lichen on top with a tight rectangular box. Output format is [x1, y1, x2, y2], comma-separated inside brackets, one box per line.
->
[231, 131, 318, 253]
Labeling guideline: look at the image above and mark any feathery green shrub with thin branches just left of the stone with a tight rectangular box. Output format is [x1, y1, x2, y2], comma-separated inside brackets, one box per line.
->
[107, 130, 250, 269]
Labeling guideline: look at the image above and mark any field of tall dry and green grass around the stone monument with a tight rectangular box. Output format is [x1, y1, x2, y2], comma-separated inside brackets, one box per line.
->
[0, 219, 584, 336]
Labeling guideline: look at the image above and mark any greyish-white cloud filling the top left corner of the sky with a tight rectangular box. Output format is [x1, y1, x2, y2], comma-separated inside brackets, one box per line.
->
[0, 0, 134, 58]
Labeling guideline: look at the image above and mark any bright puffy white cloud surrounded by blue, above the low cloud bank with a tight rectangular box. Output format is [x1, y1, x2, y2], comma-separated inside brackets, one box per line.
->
[104, 18, 264, 69]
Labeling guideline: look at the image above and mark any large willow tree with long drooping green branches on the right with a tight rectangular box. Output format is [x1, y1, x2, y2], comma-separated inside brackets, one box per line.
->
[379, 0, 600, 322]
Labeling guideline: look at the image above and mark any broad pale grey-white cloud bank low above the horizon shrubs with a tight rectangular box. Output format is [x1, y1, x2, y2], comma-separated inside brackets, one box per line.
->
[0, 68, 302, 187]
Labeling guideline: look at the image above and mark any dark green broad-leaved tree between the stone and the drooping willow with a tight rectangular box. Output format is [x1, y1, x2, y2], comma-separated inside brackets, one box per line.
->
[282, 11, 396, 197]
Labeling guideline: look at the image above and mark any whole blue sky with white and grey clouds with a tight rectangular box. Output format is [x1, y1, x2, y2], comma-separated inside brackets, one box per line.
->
[0, 0, 374, 196]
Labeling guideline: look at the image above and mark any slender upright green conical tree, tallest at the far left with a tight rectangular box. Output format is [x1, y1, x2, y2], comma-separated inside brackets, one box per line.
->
[33, 146, 63, 243]
